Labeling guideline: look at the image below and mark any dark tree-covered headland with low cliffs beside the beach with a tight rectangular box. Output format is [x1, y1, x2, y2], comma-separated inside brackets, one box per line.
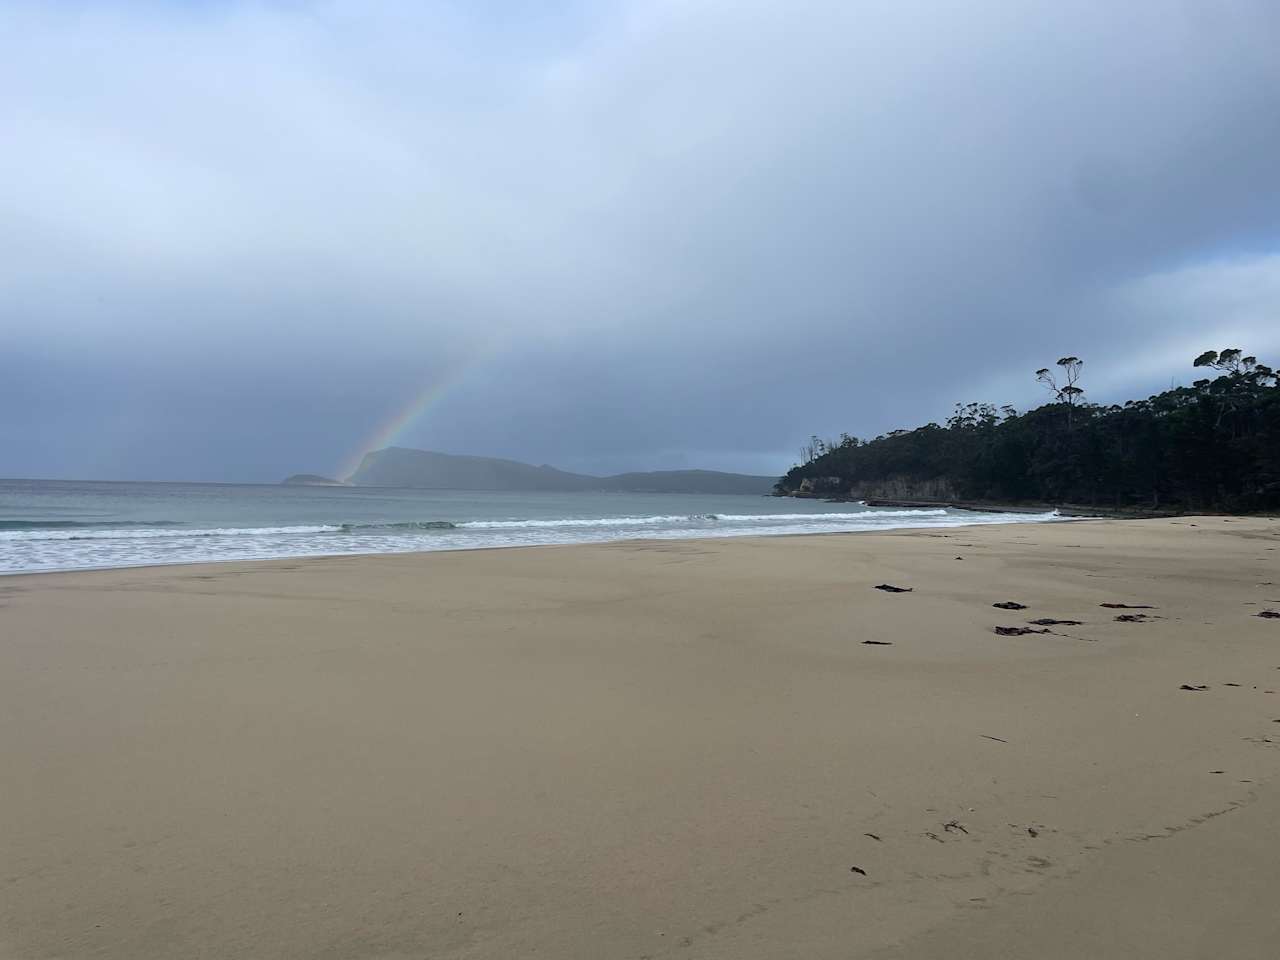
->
[776, 348, 1280, 511]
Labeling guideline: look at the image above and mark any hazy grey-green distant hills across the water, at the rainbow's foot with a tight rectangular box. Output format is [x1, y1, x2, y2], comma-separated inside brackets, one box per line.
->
[346, 447, 777, 495]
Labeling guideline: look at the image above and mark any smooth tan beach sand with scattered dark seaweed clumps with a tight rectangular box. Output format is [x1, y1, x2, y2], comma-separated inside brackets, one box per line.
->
[0, 517, 1280, 960]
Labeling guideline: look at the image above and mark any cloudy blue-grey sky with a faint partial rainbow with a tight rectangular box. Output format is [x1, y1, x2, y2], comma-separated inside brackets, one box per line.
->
[0, 0, 1280, 481]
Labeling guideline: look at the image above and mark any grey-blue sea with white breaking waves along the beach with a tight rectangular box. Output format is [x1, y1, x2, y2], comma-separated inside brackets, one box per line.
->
[0, 480, 1055, 573]
